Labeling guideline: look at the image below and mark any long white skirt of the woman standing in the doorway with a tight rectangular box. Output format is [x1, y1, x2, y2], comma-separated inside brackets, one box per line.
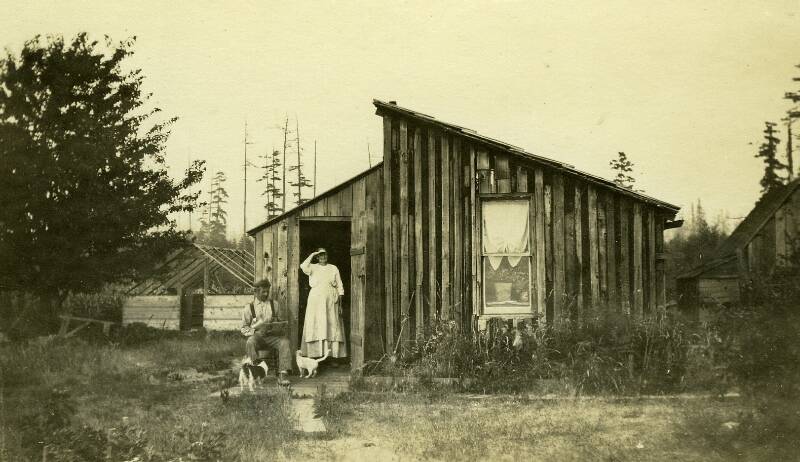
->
[300, 284, 347, 358]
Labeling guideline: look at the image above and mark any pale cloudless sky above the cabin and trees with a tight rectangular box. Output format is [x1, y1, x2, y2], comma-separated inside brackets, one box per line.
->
[0, 0, 800, 235]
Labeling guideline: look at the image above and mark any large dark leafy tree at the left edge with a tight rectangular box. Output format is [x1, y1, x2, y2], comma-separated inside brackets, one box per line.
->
[0, 34, 204, 327]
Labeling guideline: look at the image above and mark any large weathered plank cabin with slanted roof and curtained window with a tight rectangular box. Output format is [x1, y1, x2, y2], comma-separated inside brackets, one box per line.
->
[248, 100, 678, 369]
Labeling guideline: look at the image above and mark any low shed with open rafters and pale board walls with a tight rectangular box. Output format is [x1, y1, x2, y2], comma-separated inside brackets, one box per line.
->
[122, 244, 255, 330]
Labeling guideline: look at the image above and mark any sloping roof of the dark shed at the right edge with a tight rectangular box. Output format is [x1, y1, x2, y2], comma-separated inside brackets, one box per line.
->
[678, 178, 800, 279]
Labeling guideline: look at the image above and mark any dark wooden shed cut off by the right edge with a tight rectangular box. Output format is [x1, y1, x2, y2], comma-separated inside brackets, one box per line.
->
[677, 179, 800, 309]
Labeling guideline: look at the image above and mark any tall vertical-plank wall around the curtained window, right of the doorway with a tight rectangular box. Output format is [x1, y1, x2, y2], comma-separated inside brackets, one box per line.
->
[382, 114, 674, 347]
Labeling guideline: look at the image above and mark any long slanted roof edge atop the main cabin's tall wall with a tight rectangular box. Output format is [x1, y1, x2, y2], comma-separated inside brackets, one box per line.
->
[372, 99, 680, 212]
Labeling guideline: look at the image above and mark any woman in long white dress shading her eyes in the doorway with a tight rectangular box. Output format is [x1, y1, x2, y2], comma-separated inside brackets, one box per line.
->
[300, 248, 347, 358]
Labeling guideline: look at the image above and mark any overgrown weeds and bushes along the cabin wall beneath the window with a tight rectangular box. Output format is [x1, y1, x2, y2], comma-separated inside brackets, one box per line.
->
[390, 316, 703, 393]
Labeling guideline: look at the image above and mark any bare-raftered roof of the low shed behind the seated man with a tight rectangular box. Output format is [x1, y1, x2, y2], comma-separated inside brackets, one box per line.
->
[128, 244, 255, 295]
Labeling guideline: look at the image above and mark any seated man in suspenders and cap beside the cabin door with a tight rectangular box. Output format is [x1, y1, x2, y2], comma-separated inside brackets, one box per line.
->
[241, 279, 292, 386]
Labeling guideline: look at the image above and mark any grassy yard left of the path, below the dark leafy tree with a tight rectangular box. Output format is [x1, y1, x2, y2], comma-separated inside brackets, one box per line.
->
[0, 327, 296, 461]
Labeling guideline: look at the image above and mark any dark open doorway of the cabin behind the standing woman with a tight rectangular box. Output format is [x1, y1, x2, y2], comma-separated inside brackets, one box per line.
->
[295, 218, 351, 365]
